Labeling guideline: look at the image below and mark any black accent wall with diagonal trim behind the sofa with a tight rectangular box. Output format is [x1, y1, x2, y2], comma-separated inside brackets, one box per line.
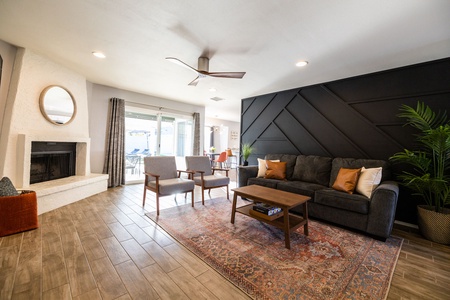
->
[241, 58, 450, 223]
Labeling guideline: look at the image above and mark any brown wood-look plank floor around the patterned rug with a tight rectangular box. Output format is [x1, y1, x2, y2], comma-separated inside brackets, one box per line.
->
[0, 172, 450, 300]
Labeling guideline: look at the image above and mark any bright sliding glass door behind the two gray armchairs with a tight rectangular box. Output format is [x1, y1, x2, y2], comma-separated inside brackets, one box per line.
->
[125, 106, 193, 183]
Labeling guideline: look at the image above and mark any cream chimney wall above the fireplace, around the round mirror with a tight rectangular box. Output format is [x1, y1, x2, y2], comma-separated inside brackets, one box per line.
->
[0, 48, 89, 187]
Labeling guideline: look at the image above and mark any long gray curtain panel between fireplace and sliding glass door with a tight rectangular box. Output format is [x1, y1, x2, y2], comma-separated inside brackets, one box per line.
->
[103, 98, 125, 187]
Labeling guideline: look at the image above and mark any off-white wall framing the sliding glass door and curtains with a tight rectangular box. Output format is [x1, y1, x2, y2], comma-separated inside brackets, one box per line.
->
[87, 83, 205, 173]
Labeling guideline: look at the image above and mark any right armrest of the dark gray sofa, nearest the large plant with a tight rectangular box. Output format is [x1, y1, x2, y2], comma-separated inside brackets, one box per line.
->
[367, 181, 399, 238]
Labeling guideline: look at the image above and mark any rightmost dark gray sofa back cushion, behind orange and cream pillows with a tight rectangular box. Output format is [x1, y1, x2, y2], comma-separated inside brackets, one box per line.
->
[329, 157, 391, 187]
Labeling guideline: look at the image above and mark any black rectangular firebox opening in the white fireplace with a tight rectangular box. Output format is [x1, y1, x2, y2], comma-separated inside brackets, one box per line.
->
[30, 142, 77, 184]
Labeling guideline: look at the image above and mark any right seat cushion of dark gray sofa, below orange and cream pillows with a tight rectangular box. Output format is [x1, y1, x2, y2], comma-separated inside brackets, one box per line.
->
[314, 188, 370, 214]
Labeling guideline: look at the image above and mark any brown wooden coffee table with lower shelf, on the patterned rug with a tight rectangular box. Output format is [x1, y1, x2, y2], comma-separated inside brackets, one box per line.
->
[231, 185, 311, 249]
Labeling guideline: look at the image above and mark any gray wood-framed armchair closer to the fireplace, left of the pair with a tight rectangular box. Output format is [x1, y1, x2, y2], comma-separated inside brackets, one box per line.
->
[142, 156, 195, 215]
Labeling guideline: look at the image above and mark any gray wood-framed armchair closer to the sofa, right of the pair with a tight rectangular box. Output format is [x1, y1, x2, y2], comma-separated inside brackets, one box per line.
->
[185, 156, 230, 205]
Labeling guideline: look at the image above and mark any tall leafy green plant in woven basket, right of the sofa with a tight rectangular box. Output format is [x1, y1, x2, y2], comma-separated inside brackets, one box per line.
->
[390, 101, 450, 244]
